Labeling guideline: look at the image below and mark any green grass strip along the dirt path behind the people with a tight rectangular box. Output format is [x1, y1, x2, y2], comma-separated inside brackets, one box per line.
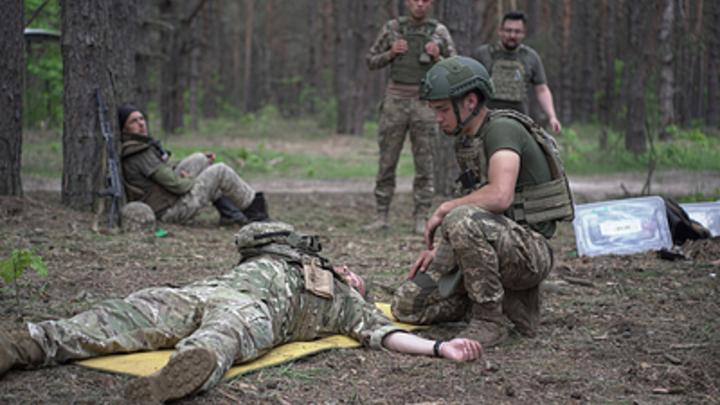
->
[21, 107, 720, 181]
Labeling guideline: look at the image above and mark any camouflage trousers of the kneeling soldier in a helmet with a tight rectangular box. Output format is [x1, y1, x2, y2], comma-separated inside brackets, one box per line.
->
[391, 206, 553, 324]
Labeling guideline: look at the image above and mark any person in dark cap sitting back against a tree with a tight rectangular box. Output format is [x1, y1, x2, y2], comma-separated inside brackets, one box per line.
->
[118, 104, 268, 226]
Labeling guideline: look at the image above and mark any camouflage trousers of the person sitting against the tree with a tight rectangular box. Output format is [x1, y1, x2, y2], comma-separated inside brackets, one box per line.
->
[160, 153, 255, 224]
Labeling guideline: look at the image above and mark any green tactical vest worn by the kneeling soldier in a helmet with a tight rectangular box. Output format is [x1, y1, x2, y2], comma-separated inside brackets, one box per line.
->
[455, 110, 575, 224]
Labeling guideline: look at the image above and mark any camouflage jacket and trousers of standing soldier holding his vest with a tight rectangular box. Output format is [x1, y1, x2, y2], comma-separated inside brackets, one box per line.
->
[366, 20, 457, 223]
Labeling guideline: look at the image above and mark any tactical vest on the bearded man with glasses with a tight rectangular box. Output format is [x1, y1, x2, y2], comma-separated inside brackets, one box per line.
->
[488, 43, 527, 102]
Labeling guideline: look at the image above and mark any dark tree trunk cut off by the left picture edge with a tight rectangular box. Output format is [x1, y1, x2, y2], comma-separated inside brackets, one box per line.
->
[0, 0, 25, 197]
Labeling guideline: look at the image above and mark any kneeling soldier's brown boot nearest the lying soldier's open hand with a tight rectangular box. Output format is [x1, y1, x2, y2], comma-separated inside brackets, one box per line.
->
[457, 303, 509, 348]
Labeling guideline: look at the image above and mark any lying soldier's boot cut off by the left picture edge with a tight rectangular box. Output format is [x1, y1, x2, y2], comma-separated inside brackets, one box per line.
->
[0, 325, 45, 375]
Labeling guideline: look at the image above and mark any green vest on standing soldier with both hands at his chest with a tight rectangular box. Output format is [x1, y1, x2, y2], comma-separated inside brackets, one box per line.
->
[390, 17, 437, 84]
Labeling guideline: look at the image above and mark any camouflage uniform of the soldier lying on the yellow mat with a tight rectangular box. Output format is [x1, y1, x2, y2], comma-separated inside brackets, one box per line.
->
[29, 255, 401, 390]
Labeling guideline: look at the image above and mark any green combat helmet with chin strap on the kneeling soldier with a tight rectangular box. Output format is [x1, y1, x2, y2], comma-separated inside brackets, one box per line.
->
[419, 56, 495, 135]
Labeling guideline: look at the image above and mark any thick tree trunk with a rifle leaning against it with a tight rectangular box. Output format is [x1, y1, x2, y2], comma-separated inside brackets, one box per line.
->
[61, 0, 136, 211]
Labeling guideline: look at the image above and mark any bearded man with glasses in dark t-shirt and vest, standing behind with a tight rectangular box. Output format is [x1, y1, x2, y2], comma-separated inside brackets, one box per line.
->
[472, 11, 562, 135]
